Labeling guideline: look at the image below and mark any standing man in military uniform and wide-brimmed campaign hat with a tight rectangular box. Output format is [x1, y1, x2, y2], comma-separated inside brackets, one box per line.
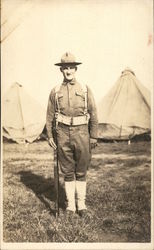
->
[46, 53, 98, 217]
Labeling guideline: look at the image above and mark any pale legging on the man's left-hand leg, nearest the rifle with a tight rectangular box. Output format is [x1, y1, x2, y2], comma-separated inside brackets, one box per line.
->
[65, 181, 76, 212]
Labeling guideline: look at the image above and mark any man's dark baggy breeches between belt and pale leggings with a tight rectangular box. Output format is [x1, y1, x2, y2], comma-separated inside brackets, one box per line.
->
[57, 124, 91, 181]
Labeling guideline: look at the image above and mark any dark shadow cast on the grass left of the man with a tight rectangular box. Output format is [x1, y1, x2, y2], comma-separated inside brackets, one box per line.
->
[18, 171, 66, 215]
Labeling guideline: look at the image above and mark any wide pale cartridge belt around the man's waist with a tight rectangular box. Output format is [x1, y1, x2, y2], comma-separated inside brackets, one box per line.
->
[56, 113, 89, 126]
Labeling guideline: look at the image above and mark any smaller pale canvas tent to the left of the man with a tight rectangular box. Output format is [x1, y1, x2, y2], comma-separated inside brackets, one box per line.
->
[2, 83, 46, 143]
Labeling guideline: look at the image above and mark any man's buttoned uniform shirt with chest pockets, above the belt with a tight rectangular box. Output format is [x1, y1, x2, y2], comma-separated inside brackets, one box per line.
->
[46, 79, 98, 138]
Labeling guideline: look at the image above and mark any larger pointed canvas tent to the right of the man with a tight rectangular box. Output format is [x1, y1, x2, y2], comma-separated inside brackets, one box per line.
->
[98, 68, 151, 140]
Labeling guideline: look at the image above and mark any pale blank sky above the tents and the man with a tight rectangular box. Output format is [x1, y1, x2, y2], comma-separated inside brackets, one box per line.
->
[1, 0, 153, 107]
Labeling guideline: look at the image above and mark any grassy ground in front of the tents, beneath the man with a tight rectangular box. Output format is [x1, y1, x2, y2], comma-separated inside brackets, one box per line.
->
[3, 141, 151, 242]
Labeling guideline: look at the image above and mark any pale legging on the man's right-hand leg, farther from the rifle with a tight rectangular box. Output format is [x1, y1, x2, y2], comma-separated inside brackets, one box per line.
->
[76, 181, 87, 214]
